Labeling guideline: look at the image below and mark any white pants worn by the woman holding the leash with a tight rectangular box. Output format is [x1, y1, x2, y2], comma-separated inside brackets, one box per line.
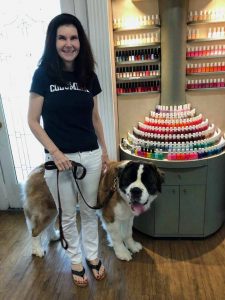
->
[45, 149, 102, 264]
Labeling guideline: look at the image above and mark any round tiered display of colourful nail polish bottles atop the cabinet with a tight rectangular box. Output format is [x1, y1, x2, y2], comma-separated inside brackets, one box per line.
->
[121, 104, 225, 160]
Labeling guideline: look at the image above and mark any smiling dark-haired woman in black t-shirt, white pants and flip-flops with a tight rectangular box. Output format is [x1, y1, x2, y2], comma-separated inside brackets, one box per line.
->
[28, 14, 108, 286]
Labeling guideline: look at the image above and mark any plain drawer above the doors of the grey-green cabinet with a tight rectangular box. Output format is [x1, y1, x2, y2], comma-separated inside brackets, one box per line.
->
[162, 166, 207, 185]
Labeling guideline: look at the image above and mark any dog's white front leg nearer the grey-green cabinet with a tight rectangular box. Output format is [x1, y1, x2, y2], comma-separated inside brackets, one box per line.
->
[122, 216, 142, 253]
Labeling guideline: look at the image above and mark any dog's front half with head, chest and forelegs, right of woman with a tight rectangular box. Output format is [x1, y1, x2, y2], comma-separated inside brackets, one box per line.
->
[98, 161, 164, 261]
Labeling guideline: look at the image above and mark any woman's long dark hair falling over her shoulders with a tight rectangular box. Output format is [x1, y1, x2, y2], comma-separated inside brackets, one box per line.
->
[39, 13, 95, 88]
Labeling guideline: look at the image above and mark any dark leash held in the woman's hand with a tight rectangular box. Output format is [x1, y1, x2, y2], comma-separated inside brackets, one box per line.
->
[44, 160, 117, 250]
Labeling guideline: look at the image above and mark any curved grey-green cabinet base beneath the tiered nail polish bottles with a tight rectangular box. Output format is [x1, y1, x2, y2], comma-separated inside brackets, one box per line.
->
[120, 147, 225, 238]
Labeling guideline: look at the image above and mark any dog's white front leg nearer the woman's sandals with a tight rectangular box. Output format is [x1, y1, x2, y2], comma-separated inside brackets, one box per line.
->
[106, 220, 132, 261]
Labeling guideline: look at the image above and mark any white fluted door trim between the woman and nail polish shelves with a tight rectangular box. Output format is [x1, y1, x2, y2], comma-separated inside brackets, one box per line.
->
[87, 0, 118, 160]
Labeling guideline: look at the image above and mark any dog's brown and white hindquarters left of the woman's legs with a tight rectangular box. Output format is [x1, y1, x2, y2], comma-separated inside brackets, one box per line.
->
[23, 165, 60, 257]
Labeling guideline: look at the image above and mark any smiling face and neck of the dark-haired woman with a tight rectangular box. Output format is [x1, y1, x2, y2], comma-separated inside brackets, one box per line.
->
[56, 25, 80, 71]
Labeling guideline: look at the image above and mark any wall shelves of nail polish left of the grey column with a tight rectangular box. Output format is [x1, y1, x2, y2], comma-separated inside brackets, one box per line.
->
[113, 14, 161, 95]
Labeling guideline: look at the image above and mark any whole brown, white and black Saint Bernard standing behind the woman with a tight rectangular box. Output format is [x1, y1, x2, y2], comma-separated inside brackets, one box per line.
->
[23, 161, 164, 261]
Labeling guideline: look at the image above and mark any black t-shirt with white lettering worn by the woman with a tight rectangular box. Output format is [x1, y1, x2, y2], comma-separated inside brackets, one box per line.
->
[30, 67, 101, 153]
